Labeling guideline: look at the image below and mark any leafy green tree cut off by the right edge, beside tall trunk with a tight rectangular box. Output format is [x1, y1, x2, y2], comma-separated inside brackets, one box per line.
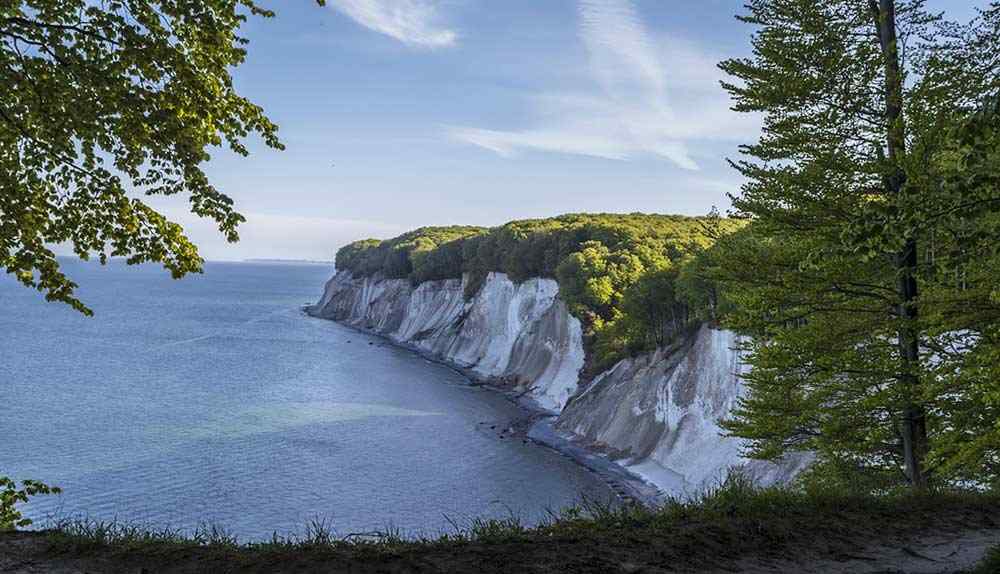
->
[925, 94, 1000, 487]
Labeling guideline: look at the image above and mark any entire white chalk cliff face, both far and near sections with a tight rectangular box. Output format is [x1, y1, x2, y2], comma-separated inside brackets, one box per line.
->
[309, 272, 808, 495]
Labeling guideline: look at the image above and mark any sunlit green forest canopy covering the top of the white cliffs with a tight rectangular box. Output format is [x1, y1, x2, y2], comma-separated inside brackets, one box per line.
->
[337, 213, 739, 365]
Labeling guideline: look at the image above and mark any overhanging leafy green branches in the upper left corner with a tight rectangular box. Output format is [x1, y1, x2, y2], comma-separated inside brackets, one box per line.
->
[0, 0, 323, 314]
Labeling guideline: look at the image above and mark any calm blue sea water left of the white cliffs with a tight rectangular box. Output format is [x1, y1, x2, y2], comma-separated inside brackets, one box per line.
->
[0, 260, 608, 540]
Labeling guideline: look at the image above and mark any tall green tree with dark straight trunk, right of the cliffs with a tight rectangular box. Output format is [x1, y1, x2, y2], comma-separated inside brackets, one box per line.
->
[719, 0, 1000, 487]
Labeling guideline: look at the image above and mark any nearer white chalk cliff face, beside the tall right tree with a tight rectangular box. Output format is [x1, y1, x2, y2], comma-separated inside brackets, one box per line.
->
[557, 326, 809, 496]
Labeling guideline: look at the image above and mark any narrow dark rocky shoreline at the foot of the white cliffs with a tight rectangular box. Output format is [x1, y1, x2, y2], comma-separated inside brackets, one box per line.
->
[300, 304, 666, 508]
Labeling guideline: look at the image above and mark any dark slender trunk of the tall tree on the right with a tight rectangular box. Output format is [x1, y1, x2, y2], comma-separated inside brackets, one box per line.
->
[870, 0, 927, 488]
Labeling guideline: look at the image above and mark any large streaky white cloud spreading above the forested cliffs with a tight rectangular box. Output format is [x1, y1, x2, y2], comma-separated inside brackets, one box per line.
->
[449, 0, 752, 170]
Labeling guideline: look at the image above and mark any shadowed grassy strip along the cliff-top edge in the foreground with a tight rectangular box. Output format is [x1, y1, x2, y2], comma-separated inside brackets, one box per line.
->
[0, 480, 1000, 573]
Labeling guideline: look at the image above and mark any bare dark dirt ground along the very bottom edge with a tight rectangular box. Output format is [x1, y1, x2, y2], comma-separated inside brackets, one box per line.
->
[0, 525, 1000, 574]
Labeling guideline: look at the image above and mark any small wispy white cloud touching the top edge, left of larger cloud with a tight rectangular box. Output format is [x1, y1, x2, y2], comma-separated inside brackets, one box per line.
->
[330, 0, 458, 48]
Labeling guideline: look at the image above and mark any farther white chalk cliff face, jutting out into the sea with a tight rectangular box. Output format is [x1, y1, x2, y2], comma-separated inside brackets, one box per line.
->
[309, 272, 584, 412]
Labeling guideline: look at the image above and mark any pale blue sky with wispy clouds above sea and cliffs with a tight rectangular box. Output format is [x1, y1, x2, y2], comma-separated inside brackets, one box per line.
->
[154, 0, 983, 260]
